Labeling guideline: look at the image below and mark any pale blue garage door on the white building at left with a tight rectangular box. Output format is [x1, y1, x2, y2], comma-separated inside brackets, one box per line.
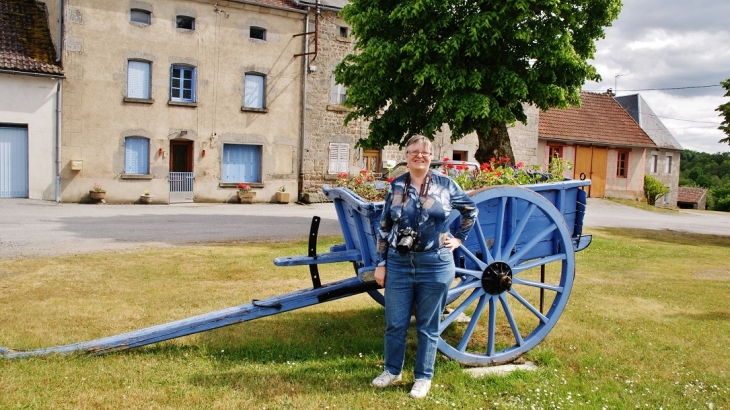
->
[0, 127, 28, 198]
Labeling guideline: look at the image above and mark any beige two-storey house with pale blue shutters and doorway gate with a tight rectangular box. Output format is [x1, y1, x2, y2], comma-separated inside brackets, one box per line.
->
[43, 0, 306, 203]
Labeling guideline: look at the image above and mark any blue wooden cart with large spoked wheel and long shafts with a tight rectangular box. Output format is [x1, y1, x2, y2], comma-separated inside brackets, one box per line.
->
[0, 180, 591, 365]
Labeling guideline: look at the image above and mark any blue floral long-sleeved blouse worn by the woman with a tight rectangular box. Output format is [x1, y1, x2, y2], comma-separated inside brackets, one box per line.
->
[376, 171, 478, 266]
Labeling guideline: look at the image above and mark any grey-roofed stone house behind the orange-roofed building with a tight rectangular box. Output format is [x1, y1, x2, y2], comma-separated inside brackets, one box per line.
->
[614, 94, 683, 208]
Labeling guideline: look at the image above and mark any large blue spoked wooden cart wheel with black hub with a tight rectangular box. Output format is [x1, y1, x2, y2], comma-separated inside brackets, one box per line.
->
[438, 186, 575, 365]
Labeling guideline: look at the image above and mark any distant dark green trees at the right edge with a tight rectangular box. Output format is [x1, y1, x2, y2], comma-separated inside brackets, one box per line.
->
[679, 150, 730, 212]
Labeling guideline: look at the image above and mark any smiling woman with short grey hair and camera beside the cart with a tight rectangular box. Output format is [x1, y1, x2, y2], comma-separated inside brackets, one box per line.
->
[372, 135, 477, 398]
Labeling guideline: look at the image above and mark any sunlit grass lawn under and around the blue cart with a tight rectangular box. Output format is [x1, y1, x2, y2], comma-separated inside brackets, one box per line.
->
[0, 229, 730, 409]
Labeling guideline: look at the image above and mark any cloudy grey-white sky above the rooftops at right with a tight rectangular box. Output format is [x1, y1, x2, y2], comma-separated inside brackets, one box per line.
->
[583, 0, 730, 153]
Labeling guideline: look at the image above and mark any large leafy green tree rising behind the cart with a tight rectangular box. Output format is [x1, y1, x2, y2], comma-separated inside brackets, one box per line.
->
[336, 0, 621, 162]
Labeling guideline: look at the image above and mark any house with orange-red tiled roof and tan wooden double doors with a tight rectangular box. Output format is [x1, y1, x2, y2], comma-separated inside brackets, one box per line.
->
[538, 92, 656, 200]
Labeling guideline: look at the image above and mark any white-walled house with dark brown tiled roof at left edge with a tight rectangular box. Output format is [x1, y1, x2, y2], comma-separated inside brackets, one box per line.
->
[0, 0, 63, 200]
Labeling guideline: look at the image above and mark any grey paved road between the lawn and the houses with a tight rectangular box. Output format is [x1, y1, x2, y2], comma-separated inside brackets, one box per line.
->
[0, 198, 730, 258]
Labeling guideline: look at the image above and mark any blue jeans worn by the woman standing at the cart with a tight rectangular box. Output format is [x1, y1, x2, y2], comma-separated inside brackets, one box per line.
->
[385, 248, 454, 380]
